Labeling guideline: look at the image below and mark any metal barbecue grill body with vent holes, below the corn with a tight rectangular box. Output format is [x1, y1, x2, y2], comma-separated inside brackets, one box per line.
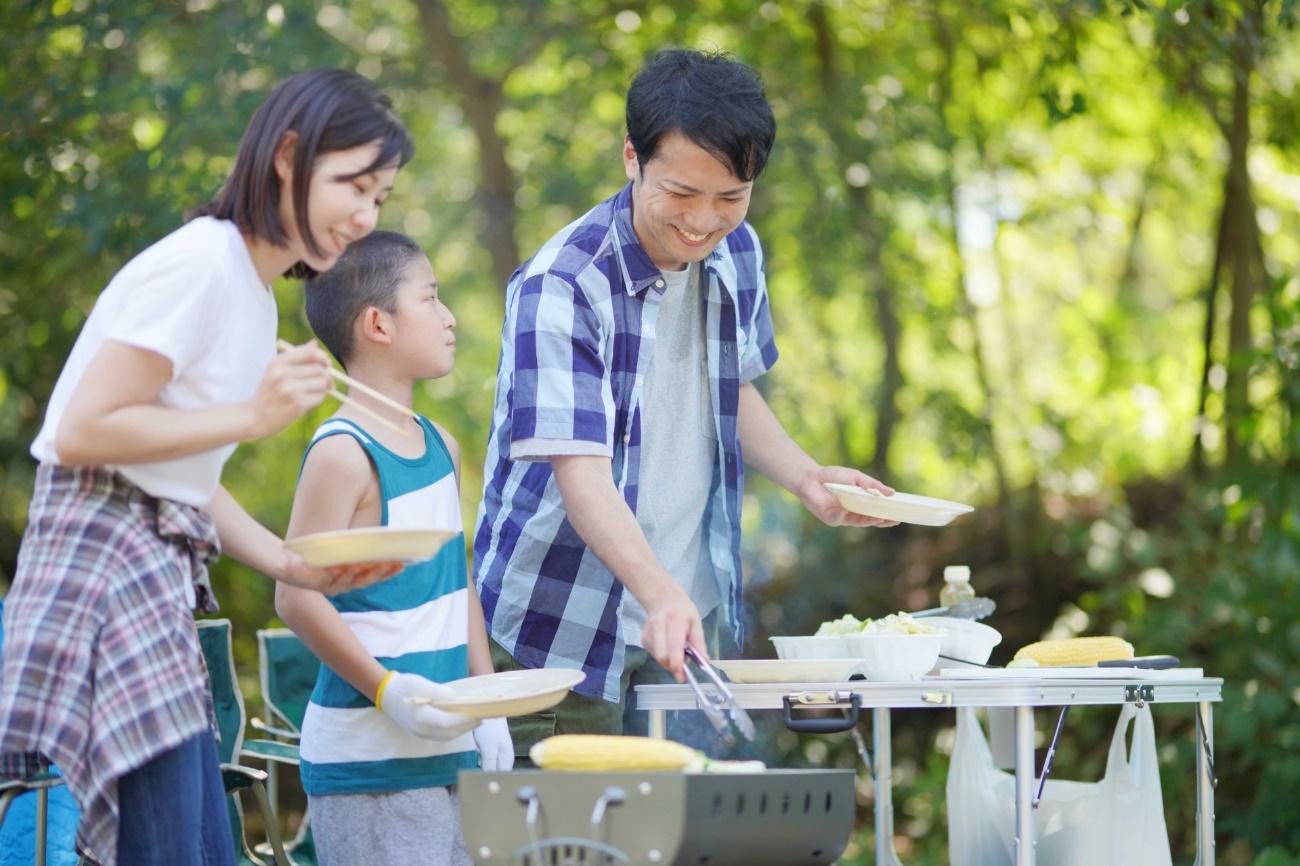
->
[459, 770, 854, 866]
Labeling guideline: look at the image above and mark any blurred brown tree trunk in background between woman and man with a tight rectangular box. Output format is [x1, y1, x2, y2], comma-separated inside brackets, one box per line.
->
[416, 0, 520, 293]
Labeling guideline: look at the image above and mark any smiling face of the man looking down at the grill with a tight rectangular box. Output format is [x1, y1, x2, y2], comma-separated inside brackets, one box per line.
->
[623, 133, 754, 270]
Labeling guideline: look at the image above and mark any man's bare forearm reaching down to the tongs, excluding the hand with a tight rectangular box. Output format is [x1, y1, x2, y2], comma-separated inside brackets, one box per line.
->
[551, 456, 681, 610]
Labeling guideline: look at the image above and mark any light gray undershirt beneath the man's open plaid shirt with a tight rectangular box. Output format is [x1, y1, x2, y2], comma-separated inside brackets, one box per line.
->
[621, 264, 722, 646]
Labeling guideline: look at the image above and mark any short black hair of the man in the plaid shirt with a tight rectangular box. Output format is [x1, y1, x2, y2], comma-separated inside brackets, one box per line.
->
[627, 48, 776, 183]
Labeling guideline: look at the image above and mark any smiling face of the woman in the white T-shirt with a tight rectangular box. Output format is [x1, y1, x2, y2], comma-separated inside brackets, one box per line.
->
[280, 142, 398, 272]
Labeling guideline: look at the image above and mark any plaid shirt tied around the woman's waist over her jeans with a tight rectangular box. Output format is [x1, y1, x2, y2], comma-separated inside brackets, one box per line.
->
[0, 464, 220, 866]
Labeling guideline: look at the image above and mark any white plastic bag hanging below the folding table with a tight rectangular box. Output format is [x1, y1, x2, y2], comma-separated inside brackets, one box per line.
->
[948, 703, 1171, 866]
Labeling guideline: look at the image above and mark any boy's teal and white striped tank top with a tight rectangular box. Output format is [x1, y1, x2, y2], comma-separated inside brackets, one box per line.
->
[300, 419, 478, 796]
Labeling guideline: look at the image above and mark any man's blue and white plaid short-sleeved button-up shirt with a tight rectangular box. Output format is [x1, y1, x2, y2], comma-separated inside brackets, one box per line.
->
[475, 185, 777, 701]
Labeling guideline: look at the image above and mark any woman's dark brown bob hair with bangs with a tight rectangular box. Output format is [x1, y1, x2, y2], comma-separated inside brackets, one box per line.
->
[192, 69, 415, 277]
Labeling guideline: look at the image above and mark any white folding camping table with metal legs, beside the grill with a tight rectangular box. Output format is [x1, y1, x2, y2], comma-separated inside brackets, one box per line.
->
[636, 668, 1223, 866]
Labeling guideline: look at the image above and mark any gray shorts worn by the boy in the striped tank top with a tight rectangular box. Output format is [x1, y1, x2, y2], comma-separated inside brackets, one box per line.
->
[307, 788, 472, 866]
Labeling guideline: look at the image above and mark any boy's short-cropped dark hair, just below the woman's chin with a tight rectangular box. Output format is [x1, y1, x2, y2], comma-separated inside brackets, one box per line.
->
[307, 231, 424, 367]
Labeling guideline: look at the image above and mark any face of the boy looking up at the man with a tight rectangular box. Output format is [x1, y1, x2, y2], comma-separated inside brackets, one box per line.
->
[391, 256, 456, 378]
